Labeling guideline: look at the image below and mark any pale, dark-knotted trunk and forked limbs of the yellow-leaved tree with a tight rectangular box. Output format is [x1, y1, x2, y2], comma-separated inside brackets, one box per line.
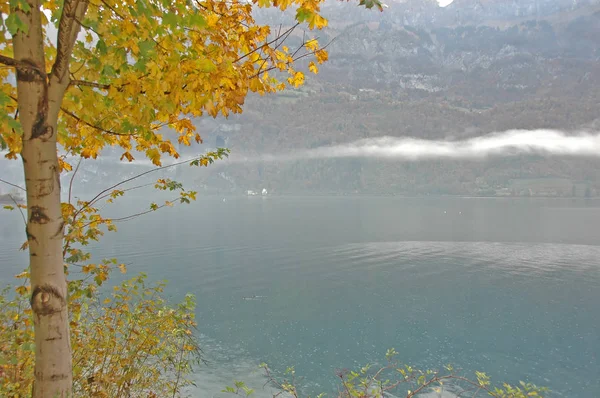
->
[11, 0, 87, 398]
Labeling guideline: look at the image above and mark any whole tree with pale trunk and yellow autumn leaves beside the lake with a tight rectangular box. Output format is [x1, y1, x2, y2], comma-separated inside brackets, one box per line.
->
[0, 0, 381, 397]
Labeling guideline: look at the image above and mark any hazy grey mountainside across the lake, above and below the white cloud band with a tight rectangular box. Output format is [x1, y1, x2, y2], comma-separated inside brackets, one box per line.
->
[184, 0, 600, 196]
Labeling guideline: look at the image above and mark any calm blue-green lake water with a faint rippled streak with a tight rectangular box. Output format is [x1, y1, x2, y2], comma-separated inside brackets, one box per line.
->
[0, 197, 600, 397]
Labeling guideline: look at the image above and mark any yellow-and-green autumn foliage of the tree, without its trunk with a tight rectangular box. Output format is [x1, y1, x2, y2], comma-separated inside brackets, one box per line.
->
[0, 0, 380, 169]
